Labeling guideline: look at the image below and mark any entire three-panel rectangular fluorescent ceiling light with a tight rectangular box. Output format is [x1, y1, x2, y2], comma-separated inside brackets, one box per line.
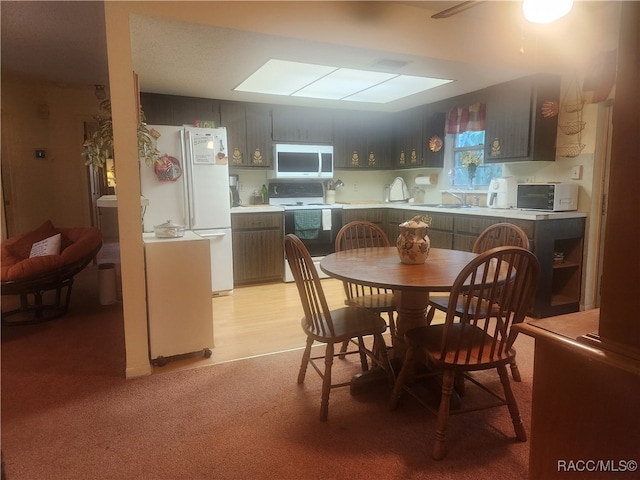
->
[235, 59, 452, 103]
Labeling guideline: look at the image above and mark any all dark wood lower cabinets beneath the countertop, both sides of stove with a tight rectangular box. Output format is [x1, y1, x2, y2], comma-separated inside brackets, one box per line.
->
[231, 208, 585, 318]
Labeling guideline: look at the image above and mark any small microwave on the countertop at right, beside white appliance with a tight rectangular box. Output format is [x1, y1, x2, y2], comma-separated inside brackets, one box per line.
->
[517, 183, 578, 212]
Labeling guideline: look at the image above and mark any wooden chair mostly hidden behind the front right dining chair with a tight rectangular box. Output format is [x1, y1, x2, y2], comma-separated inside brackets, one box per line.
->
[427, 223, 529, 385]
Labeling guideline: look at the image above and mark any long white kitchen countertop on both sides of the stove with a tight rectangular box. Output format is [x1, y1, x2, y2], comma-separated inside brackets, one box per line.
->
[231, 202, 587, 220]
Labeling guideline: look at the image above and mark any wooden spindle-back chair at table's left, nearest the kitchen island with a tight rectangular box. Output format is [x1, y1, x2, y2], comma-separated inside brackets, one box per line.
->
[284, 234, 393, 421]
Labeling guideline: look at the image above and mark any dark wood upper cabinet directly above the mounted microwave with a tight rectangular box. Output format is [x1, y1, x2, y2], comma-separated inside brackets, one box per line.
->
[272, 105, 333, 144]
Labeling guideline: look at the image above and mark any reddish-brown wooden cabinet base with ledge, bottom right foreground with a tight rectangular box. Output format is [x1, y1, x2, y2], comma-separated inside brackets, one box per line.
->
[518, 309, 640, 480]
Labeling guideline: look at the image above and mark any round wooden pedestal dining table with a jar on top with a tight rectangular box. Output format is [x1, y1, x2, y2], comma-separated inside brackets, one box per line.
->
[320, 246, 477, 353]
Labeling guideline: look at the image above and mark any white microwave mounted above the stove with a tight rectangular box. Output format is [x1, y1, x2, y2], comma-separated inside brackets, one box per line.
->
[267, 143, 333, 180]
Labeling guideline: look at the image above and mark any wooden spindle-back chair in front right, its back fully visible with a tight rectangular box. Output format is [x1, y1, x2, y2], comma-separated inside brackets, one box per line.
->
[390, 247, 540, 460]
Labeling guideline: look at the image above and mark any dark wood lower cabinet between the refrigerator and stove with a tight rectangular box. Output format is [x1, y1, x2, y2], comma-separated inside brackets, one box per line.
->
[231, 213, 284, 286]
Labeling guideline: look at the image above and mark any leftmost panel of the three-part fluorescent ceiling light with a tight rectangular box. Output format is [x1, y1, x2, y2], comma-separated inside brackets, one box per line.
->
[234, 59, 337, 95]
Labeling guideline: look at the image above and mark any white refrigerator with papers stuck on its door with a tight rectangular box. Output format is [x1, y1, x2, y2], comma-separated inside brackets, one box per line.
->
[140, 125, 233, 295]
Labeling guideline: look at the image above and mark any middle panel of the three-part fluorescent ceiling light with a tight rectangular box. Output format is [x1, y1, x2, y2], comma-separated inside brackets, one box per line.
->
[292, 68, 397, 100]
